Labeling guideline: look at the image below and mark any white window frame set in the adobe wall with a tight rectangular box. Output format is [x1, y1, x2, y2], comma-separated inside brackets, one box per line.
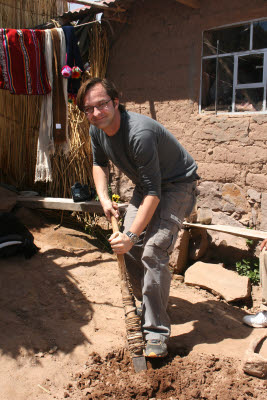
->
[199, 17, 267, 115]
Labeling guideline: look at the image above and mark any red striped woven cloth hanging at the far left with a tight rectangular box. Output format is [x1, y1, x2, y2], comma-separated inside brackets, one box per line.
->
[0, 29, 51, 95]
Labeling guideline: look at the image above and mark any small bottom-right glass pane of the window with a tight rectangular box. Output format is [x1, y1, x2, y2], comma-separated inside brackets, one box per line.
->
[235, 88, 263, 112]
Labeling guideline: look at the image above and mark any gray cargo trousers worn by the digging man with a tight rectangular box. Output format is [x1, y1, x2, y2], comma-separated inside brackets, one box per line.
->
[124, 182, 196, 342]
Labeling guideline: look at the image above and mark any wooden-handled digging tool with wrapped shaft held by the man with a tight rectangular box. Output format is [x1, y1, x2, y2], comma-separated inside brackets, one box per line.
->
[111, 216, 147, 372]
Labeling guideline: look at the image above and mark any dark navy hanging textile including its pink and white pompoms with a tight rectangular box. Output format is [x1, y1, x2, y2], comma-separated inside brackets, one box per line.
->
[62, 26, 84, 102]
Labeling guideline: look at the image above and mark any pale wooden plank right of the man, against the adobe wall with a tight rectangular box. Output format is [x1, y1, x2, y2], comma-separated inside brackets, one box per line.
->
[183, 222, 267, 239]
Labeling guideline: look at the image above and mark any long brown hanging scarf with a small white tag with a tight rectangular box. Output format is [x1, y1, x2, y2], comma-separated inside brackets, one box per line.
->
[51, 28, 69, 154]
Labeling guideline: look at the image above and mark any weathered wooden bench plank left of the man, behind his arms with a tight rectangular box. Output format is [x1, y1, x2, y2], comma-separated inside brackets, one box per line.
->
[17, 196, 127, 214]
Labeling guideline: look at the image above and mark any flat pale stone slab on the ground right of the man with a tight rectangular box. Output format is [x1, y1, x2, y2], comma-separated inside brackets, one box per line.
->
[184, 261, 251, 302]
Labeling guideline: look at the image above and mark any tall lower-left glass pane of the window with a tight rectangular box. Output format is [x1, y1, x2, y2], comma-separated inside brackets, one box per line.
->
[202, 57, 234, 112]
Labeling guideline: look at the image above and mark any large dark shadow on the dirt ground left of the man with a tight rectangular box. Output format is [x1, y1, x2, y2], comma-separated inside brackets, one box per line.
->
[0, 249, 99, 358]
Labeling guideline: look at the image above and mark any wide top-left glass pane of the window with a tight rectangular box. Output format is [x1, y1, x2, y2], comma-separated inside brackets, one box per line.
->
[203, 24, 250, 56]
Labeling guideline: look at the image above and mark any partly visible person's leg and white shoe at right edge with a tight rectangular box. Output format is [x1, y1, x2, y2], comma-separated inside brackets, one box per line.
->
[243, 239, 267, 328]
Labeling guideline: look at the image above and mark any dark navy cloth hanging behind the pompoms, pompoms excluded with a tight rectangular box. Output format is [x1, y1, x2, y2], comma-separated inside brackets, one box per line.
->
[62, 26, 84, 97]
